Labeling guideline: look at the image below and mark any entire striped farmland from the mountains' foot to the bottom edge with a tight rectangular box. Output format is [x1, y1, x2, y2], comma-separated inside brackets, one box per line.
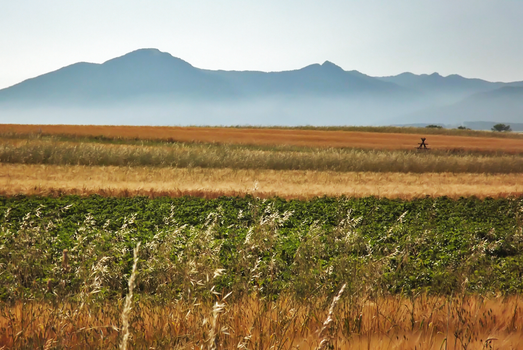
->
[0, 125, 523, 349]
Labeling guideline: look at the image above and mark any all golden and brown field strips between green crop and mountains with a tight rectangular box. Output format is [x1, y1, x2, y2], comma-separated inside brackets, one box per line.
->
[0, 125, 523, 199]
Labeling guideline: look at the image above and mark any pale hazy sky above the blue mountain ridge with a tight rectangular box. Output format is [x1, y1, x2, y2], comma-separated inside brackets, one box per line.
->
[0, 0, 523, 88]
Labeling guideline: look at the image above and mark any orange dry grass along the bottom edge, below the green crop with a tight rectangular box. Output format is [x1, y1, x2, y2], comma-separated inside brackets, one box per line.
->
[0, 296, 523, 350]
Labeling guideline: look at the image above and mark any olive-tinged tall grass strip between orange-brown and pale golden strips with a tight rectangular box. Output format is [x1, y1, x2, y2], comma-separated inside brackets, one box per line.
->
[0, 140, 523, 174]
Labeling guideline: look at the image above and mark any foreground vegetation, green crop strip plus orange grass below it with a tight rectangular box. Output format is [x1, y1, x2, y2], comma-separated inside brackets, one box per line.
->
[0, 196, 523, 349]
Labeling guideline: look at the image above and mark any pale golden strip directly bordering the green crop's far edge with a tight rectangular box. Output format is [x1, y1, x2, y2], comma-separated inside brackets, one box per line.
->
[0, 164, 523, 199]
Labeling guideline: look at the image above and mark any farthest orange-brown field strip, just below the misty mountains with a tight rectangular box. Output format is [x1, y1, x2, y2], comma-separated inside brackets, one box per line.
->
[0, 124, 523, 153]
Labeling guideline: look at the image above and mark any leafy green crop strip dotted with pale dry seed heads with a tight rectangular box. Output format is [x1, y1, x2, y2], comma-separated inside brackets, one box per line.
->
[0, 196, 523, 300]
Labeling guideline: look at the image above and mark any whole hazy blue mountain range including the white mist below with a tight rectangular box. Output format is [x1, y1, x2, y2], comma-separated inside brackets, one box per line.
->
[0, 49, 523, 125]
